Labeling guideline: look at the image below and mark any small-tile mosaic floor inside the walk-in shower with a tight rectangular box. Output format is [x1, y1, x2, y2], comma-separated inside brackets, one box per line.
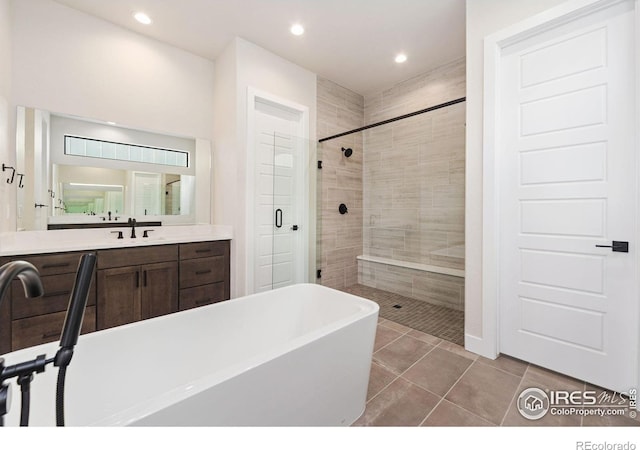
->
[344, 284, 464, 345]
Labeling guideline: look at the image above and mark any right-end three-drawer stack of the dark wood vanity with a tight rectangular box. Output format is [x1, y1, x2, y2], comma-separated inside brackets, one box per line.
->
[179, 241, 230, 311]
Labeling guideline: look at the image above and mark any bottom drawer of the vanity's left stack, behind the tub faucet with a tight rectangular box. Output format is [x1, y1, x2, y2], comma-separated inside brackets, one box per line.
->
[11, 306, 96, 351]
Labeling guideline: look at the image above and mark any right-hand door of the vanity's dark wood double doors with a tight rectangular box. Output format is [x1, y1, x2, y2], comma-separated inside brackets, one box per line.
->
[140, 262, 178, 319]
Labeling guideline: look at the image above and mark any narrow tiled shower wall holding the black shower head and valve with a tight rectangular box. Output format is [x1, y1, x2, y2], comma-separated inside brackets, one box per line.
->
[317, 78, 364, 289]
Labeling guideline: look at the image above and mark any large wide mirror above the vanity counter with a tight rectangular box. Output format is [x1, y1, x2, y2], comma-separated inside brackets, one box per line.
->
[16, 107, 211, 231]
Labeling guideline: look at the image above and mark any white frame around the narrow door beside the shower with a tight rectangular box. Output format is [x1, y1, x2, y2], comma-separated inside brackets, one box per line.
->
[245, 86, 310, 294]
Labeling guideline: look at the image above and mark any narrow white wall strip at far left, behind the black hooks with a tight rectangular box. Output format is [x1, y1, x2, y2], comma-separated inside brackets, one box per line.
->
[0, 0, 16, 232]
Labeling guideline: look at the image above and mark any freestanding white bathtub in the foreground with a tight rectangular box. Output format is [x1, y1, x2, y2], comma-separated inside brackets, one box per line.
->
[4, 284, 378, 426]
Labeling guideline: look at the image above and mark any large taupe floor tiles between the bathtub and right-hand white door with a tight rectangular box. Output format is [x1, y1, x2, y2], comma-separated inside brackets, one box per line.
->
[354, 318, 640, 426]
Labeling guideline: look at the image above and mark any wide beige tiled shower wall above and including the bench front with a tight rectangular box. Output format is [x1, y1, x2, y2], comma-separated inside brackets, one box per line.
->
[359, 59, 465, 309]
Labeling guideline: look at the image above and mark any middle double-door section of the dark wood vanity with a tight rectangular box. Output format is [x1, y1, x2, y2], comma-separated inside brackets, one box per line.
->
[97, 245, 178, 330]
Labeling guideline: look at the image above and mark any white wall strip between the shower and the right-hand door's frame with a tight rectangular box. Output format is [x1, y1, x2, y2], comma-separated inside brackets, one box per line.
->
[465, 0, 564, 348]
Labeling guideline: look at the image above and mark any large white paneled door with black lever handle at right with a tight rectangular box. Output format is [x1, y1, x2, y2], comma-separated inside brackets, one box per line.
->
[497, 1, 639, 391]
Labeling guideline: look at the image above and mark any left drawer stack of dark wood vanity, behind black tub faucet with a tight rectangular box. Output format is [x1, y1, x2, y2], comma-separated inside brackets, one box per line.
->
[0, 252, 96, 350]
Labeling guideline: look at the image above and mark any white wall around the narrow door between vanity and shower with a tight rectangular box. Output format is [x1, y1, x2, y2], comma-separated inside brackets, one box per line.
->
[214, 38, 316, 297]
